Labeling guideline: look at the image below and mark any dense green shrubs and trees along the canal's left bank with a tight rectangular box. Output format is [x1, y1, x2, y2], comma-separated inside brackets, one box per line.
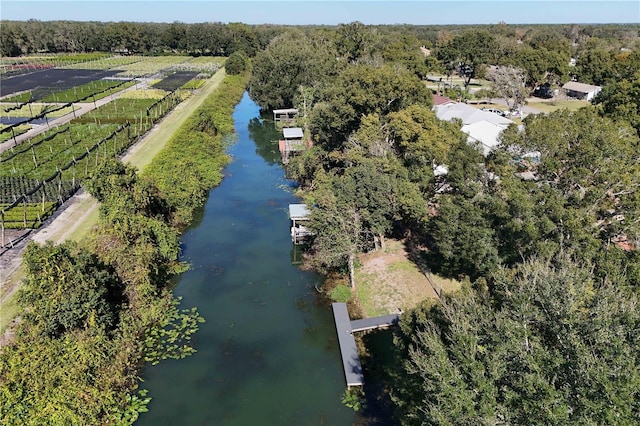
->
[0, 73, 248, 425]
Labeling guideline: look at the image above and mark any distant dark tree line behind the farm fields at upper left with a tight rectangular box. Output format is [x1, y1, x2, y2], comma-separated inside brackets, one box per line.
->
[0, 20, 283, 56]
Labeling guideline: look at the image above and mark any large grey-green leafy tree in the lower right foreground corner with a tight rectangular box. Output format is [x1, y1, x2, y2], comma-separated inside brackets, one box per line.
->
[391, 257, 640, 425]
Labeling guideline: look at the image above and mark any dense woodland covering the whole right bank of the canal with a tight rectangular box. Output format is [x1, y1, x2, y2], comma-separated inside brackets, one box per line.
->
[249, 22, 640, 424]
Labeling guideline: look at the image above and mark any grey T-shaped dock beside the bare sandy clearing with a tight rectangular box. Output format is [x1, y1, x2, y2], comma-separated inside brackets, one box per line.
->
[331, 303, 400, 387]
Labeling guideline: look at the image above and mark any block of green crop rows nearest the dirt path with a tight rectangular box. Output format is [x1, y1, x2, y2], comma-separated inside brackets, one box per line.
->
[0, 66, 202, 227]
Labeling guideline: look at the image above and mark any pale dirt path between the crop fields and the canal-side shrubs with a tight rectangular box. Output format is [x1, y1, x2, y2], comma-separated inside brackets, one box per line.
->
[0, 68, 225, 330]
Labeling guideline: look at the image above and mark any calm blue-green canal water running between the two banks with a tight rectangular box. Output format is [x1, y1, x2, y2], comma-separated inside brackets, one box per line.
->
[136, 94, 355, 426]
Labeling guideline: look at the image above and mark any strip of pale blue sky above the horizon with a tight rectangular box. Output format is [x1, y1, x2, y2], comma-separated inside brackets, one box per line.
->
[0, 0, 640, 25]
